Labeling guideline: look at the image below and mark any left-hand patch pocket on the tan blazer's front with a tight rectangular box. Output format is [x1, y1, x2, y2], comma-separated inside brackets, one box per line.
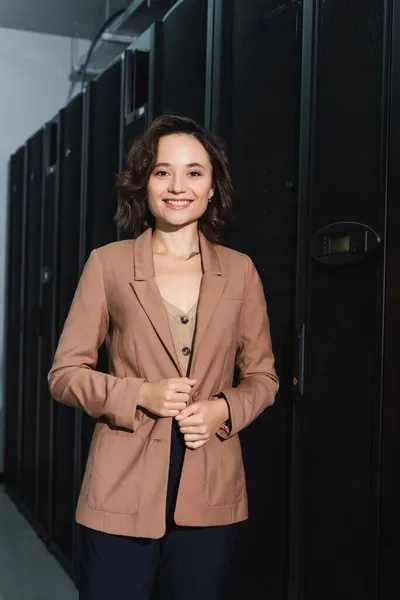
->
[88, 432, 144, 515]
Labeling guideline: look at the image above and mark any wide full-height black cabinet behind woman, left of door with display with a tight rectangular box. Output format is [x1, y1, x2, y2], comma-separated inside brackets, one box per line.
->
[206, 0, 301, 600]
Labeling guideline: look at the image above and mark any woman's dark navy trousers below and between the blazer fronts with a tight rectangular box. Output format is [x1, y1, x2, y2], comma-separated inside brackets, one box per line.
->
[79, 422, 236, 600]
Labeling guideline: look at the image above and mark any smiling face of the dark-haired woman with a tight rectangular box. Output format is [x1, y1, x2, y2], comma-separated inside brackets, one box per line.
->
[147, 134, 214, 228]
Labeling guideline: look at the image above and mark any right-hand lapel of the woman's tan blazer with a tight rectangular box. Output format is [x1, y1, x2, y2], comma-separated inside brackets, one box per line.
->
[193, 232, 226, 361]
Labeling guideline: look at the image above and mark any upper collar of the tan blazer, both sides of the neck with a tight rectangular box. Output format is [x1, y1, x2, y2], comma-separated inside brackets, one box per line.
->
[133, 227, 222, 281]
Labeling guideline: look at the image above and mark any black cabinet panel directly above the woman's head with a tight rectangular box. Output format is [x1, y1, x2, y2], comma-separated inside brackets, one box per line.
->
[155, 0, 207, 123]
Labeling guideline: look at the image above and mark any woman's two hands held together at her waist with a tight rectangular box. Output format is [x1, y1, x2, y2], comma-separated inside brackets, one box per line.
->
[138, 377, 229, 450]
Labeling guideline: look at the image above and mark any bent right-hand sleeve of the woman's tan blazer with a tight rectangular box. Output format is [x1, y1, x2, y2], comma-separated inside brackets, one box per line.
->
[216, 257, 279, 439]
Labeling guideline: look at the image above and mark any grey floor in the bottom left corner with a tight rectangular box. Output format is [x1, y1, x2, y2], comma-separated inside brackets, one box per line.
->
[0, 486, 78, 600]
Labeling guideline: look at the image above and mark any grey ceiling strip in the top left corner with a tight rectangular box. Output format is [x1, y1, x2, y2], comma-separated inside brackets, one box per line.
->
[0, 0, 130, 39]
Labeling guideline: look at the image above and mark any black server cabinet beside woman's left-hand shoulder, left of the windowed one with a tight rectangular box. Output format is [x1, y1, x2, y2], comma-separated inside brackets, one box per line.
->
[74, 60, 122, 579]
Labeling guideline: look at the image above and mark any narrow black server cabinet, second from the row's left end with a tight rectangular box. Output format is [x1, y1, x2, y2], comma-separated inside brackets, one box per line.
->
[21, 130, 43, 516]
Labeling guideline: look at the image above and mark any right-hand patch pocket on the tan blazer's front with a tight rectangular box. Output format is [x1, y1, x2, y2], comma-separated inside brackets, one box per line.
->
[204, 435, 245, 506]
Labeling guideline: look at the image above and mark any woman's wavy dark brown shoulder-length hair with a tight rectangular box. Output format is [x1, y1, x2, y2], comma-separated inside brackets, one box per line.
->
[115, 115, 234, 242]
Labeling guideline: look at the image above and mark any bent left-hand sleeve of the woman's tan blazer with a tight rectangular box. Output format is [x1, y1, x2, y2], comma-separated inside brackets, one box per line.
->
[48, 250, 145, 431]
